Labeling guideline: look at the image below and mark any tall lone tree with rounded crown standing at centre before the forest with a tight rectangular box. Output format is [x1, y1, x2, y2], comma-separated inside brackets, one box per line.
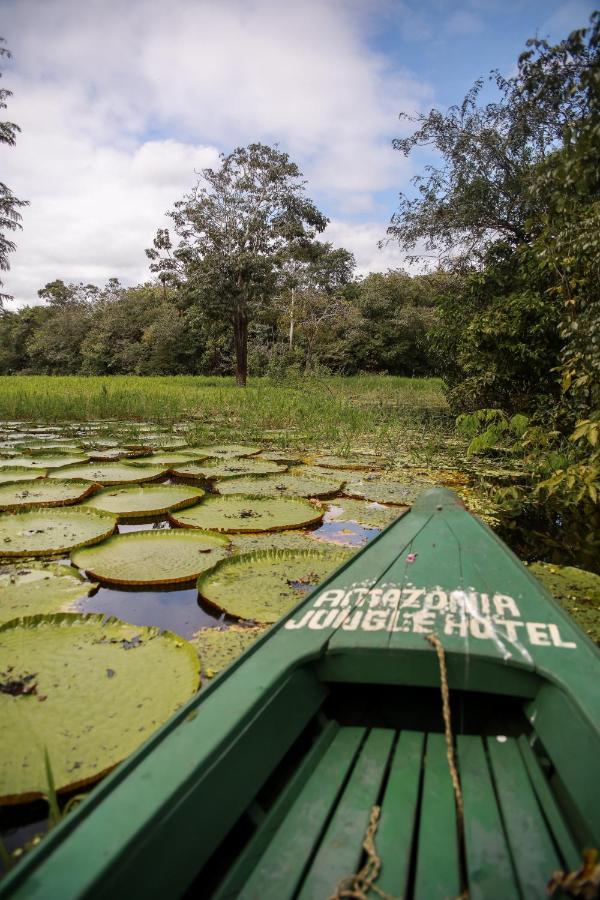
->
[146, 144, 327, 385]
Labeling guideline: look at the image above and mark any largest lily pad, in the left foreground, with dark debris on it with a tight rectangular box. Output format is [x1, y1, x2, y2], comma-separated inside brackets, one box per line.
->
[0, 614, 199, 803]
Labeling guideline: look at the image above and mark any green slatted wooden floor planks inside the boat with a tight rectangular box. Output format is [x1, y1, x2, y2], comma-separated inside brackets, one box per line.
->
[213, 723, 579, 900]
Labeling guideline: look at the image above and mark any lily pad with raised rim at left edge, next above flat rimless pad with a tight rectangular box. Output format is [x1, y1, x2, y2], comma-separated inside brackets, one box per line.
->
[0, 507, 116, 556]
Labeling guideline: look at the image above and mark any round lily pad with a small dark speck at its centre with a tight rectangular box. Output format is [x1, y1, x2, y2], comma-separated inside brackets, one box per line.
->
[169, 494, 323, 534]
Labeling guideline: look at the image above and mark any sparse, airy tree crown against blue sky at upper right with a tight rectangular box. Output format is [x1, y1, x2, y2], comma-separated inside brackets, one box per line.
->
[387, 22, 597, 267]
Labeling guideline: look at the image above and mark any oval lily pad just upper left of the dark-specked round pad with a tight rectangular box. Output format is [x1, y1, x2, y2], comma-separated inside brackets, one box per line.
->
[82, 484, 204, 519]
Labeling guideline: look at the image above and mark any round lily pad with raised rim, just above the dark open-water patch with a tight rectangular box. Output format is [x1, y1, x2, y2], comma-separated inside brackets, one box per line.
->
[71, 531, 228, 588]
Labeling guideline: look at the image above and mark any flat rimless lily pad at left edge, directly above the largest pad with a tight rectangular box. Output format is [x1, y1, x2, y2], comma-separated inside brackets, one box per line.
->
[0, 563, 98, 624]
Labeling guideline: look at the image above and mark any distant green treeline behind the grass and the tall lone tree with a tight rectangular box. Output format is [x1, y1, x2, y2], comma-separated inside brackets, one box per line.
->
[0, 268, 456, 376]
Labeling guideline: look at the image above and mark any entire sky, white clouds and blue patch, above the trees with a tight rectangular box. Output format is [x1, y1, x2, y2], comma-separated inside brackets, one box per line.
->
[0, 0, 594, 309]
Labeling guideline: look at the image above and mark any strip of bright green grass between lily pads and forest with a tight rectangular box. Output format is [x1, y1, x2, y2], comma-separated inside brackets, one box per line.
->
[0, 375, 452, 450]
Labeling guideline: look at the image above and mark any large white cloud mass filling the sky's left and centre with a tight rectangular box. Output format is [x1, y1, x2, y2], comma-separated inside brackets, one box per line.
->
[1, 0, 429, 302]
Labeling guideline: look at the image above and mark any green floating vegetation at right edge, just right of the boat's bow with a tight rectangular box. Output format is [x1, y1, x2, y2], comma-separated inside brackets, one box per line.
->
[529, 562, 600, 644]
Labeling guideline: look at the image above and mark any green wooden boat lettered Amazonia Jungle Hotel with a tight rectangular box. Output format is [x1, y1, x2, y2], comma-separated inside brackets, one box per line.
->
[0, 490, 600, 900]
